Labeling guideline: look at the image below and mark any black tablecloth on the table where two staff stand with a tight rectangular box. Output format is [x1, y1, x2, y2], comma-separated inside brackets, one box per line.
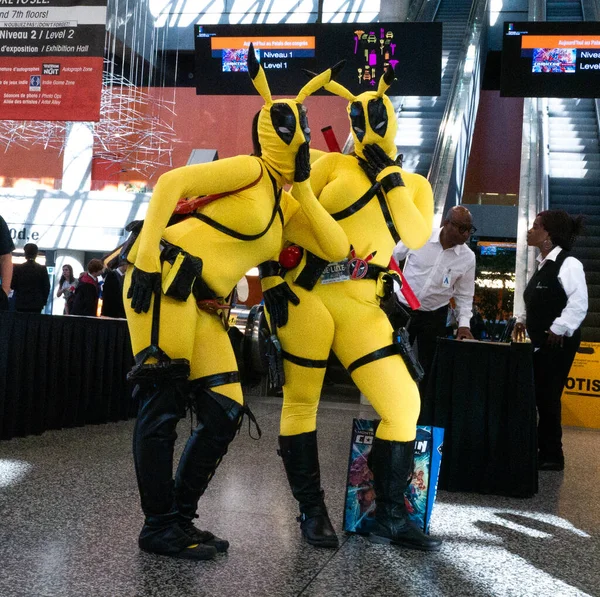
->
[420, 339, 537, 497]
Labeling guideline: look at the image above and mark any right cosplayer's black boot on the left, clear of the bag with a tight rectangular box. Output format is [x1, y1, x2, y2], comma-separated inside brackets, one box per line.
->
[279, 431, 339, 547]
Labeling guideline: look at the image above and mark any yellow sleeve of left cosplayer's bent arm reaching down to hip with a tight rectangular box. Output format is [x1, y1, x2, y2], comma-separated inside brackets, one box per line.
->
[135, 156, 262, 272]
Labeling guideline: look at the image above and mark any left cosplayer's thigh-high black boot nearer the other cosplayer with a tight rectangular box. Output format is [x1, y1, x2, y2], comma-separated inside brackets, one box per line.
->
[175, 382, 246, 552]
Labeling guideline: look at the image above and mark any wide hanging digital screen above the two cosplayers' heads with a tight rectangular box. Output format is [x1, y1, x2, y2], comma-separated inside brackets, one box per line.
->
[194, 23, 442, 96]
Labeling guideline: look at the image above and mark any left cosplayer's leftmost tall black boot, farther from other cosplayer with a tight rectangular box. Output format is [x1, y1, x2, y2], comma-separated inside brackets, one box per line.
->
[133, 382, 217, 560]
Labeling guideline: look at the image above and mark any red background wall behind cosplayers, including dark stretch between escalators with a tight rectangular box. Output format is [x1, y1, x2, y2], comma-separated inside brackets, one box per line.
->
[0, 88, 523, 193]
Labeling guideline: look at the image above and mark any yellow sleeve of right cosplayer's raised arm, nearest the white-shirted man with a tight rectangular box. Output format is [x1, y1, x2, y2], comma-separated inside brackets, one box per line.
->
[386, 170, 433, 249]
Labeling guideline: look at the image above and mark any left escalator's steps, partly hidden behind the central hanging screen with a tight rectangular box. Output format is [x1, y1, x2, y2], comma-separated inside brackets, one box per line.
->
[397, 0, 472, 176]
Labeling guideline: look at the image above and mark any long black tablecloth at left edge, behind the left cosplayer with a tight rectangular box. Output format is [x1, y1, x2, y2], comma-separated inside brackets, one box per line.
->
[0, 312, 136, 439]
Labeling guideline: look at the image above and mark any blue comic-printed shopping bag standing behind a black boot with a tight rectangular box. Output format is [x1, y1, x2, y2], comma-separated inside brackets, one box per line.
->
[343, 419, 444, 534]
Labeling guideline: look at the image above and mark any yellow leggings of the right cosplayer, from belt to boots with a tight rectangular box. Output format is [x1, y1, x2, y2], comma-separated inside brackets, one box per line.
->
[278, 280, 420, 441]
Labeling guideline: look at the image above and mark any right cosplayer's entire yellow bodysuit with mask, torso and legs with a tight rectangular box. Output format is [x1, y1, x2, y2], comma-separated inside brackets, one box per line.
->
[270, 71, 433, 441]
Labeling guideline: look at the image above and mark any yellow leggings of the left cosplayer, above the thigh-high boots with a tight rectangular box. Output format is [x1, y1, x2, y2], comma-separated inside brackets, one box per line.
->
[124, 267, 244, 404]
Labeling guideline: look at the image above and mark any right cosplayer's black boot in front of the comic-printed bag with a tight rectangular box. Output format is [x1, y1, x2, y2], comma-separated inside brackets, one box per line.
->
[369, 437, 442, 551]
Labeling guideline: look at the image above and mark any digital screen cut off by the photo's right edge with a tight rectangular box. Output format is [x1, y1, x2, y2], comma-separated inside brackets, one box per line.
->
[500, 22, 600, 97]
